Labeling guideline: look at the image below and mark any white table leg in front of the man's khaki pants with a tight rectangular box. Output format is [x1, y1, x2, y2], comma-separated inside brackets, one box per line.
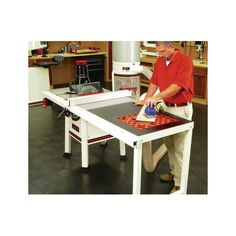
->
[180, 129, 193, 194]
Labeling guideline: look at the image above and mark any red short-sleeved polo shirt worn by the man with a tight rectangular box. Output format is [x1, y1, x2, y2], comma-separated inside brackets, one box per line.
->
[150, 50, 194, 104]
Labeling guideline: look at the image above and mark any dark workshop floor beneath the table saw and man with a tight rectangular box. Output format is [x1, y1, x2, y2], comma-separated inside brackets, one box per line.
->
[29, 88, 207, 194]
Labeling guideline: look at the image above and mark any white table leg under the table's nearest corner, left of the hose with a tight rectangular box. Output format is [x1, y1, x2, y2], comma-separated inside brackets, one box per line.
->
[133, 143, 142, 194]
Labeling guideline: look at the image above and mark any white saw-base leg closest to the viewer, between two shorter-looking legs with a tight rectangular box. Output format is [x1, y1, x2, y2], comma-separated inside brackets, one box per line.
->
[80, 119, 89, 168]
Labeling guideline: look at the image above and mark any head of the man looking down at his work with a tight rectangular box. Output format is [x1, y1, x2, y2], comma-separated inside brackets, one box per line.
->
[156, 41, 175, 61]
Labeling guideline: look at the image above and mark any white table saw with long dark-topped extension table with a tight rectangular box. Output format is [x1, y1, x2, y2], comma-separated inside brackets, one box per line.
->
[43, 89, 194, 194]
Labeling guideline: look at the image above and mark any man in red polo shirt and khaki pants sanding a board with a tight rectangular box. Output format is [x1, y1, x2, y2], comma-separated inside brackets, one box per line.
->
[136, 41, 193, 193]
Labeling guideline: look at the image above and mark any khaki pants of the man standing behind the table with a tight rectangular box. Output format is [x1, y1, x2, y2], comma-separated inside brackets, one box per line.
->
[162, 104, 193, 186]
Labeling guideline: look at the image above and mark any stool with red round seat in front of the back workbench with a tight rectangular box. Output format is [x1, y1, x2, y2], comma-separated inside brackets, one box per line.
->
[75, 60, 90, 84]
